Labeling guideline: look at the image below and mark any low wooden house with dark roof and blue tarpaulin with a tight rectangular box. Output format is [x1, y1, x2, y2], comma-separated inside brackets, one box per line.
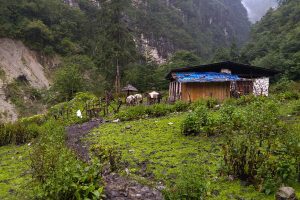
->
[166, 61, 278, 101]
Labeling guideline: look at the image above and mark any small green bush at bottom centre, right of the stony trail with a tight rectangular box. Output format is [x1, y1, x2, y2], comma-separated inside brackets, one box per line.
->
[163, 165, 208, 200]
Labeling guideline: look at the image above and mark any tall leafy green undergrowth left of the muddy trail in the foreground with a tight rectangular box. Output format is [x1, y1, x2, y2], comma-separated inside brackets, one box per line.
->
[31, 120, 103, 199]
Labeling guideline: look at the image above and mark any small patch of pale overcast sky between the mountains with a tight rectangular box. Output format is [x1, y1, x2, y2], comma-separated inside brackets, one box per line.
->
[243, 0, 277, 23]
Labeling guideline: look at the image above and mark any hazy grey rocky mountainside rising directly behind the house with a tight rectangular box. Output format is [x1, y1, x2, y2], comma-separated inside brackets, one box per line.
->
[129, 0, 250, 58]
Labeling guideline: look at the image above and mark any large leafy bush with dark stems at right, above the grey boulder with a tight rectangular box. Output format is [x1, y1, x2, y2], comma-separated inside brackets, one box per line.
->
[223, 101, 296, 193]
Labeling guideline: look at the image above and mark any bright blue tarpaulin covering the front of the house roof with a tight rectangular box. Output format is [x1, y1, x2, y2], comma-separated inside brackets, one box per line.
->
[174, 72, 241, 83]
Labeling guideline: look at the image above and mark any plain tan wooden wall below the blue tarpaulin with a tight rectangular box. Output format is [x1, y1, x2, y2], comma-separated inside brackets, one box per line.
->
[181, 82, 230, 102]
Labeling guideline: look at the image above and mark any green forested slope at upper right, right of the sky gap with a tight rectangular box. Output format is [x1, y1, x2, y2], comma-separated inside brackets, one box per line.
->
[243, 0, 300, 80]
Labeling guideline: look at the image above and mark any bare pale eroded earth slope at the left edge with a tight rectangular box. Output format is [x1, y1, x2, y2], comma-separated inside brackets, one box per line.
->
[0, 38, 58, 121]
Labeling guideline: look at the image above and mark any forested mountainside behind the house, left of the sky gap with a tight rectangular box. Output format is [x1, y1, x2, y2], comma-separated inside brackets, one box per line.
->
[0, 0, 250, 116]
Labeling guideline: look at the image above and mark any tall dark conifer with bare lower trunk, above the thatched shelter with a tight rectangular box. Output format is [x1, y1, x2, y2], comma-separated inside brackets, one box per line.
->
[96, 0, 137, 92]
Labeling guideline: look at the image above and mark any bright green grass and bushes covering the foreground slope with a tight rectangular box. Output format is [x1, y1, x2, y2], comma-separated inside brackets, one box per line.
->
[0, 88, 300, 199]
